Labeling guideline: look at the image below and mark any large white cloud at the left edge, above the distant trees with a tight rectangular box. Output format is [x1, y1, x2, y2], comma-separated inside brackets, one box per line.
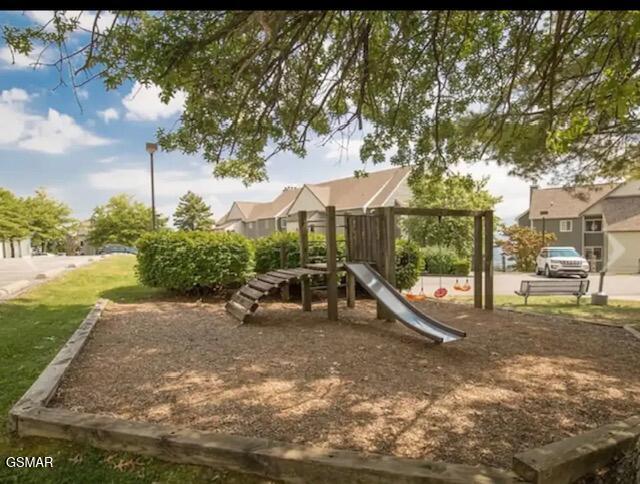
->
[0, 88, 111, 154]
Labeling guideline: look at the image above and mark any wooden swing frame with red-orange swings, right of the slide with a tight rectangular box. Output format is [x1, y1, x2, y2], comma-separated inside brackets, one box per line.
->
[393, 207, 493, 309]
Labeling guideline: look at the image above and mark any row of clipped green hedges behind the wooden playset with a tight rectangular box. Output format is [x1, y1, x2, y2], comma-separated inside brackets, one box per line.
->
[136, 231, 424, 292]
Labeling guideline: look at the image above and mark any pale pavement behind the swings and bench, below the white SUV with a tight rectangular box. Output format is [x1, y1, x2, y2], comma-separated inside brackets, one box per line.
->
[412, 272, 640, 301]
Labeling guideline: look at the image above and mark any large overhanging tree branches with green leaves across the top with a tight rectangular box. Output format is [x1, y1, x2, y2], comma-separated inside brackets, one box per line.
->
[3, 10, 640, 183]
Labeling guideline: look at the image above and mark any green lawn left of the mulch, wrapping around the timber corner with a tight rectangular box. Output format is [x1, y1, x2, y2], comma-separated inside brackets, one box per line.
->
[0, 256, 264, 483]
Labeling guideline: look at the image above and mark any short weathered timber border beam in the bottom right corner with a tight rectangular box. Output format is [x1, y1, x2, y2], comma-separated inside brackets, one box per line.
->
[513, 415, 640, 484]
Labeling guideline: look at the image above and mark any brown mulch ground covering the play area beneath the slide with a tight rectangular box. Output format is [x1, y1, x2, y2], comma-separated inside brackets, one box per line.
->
[53, 300, 640, 467]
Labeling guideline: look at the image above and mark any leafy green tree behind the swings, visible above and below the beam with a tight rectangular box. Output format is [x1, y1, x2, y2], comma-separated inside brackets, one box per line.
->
[403, 175, 501, 258]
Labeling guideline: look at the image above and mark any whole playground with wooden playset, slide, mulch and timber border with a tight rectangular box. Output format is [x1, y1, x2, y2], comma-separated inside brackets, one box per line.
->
[12, 207, 640, 482]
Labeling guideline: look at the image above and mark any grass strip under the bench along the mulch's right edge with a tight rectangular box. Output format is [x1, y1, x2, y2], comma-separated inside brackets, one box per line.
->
[455, 295, 640, 326]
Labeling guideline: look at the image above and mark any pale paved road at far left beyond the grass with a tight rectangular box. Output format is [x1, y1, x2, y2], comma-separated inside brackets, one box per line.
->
[0, 256, 100, 296]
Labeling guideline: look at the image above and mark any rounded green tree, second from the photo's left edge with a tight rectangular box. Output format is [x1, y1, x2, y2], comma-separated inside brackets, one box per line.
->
[24, 188, 73, 252]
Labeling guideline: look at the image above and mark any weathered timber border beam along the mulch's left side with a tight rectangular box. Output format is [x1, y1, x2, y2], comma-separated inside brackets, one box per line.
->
[9, 299, 109, 431]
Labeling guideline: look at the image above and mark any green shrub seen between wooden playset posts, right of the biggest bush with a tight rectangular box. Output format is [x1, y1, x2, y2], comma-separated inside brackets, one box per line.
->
[254, 232, 345, 274]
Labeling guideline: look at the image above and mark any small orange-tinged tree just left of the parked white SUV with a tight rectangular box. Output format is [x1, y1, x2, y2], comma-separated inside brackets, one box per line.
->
[498, 224, 556, 272]
